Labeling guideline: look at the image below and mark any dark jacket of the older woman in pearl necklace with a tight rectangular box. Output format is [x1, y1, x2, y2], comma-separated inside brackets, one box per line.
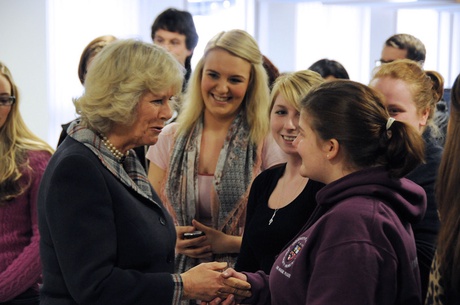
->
[38, 137, 176, 305]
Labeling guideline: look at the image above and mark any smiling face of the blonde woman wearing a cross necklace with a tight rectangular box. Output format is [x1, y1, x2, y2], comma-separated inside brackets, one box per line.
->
[270, 94, 300, 155]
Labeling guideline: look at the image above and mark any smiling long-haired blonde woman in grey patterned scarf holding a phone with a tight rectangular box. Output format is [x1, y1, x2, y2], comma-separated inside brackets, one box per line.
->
[147, 30, 285, 280]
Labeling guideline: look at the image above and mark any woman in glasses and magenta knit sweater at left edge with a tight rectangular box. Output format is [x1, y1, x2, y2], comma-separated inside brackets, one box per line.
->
[0, 62, 53, 305]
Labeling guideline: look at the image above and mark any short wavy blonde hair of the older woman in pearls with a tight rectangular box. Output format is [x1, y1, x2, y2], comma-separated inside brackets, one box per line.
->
[74, 39, 184, 134]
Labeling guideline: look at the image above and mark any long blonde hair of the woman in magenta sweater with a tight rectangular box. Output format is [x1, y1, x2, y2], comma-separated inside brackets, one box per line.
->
[0, 62, 54, 203]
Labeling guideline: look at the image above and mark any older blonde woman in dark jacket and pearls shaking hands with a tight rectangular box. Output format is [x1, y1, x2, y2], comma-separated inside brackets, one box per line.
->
[39, 39, 250, 305]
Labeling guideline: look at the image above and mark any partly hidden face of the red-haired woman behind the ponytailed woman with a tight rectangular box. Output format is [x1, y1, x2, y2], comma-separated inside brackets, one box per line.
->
[370, 76, 429, 133]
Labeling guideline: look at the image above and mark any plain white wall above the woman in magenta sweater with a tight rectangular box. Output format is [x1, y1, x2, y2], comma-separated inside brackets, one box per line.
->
[0, 0, 50, 139]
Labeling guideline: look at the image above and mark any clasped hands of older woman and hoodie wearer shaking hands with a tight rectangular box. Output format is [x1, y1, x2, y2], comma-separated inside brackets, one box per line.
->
[181, 262, 251, 305]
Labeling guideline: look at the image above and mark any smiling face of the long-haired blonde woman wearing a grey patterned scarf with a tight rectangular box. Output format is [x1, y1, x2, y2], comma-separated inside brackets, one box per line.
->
[201, 48, 251, 120]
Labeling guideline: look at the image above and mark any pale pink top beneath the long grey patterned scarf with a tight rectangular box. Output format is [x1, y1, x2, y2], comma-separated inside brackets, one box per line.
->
[146, 123, 287, 225]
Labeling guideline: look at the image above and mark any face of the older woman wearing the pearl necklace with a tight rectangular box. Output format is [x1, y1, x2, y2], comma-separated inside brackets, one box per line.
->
[129, 90, 172, 147]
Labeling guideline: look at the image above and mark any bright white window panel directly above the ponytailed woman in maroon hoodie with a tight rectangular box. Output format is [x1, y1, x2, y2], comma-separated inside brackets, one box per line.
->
[296, 3, 370, 83]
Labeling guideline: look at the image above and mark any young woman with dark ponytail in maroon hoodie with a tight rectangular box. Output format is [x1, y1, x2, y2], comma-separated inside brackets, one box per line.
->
[215, 81, 426, 305]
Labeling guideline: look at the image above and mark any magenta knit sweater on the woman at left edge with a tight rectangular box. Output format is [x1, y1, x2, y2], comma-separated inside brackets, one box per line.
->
[0, 151, 51, 302]
